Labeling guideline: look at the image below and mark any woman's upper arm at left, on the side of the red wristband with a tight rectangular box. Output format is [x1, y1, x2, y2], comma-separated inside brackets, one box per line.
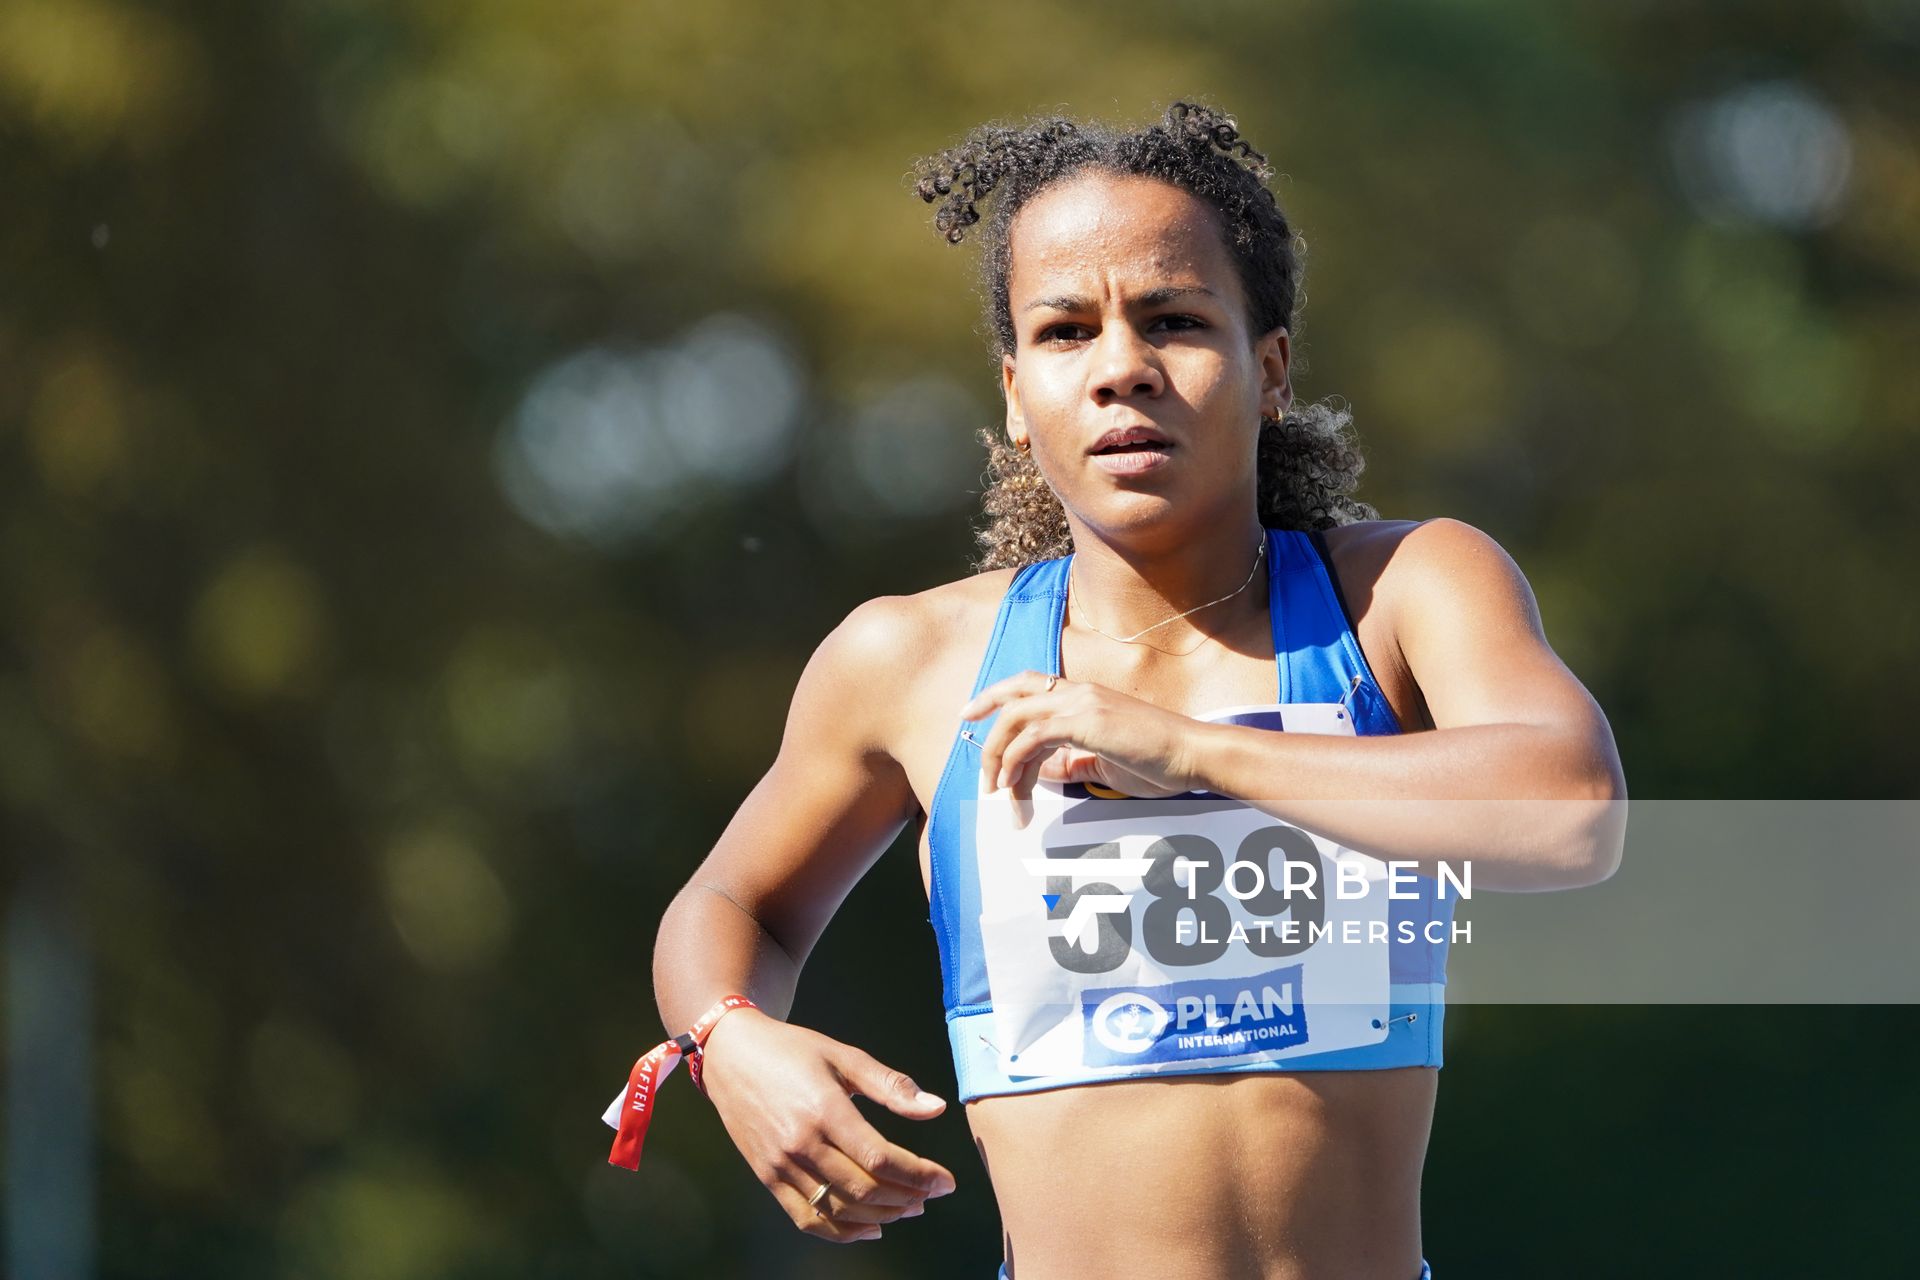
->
[693, 597, 918, 965]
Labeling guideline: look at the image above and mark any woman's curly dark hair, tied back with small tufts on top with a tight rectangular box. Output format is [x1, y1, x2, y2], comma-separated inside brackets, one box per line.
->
[914, 102, 1379, 572]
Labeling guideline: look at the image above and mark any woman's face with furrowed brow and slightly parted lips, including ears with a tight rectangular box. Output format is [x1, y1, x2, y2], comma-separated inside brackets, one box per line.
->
[1000, 173, 1292, 532]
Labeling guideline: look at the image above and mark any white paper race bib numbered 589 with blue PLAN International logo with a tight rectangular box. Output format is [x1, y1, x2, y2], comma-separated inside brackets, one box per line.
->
[975, 702, 1390, 1077]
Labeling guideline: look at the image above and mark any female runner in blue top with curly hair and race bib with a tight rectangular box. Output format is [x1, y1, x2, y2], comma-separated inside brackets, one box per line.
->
[614, 104, 1624, 1280]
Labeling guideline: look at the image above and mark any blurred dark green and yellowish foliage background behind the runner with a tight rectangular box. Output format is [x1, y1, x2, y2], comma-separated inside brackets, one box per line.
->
[0, 0, 1920, 1280]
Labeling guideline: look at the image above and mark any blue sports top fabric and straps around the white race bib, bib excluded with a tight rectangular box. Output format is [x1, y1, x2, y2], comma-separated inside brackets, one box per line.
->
[927, 530, 1453, 1102]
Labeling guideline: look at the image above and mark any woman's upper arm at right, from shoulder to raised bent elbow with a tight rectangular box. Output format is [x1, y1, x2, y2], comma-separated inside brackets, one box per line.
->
[1386, 516, 1626, 798]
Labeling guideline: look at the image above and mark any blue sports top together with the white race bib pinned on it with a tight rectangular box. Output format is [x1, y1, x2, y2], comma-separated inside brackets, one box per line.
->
[927, 530, 1453, 1102]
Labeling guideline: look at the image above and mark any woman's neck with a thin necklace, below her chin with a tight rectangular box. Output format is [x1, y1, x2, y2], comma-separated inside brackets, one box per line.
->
[1073, 512, 1267, 645]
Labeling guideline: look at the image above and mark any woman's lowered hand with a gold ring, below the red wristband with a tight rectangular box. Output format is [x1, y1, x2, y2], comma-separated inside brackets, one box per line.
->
[701, 1009, 954, 1244]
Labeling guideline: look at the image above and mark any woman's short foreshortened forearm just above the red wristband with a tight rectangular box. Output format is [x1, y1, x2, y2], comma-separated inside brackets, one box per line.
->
[653, 881, 801, 1036]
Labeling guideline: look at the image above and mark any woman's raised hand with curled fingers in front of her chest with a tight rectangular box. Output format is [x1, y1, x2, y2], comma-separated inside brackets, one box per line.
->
[960, 672, 1200, 808]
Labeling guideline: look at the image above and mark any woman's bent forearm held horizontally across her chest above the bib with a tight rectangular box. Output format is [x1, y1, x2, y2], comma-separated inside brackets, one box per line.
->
[1190, 723, 1626, 890]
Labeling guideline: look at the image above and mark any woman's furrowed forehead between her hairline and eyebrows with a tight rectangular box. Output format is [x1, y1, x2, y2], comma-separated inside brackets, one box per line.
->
[1008, 171, 1235, 297]
